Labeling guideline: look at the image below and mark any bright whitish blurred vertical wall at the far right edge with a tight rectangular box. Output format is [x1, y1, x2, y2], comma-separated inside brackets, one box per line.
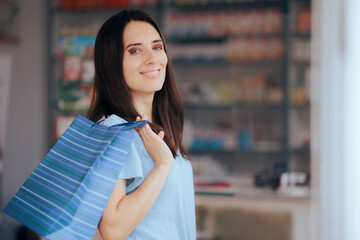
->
[311, 0, 360, 240]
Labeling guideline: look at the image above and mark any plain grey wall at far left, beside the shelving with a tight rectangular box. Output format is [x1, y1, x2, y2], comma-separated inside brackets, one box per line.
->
[0, 0, 48, 240]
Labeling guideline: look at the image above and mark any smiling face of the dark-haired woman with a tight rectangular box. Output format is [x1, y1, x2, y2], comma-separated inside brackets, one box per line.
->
[123, 21, 168, 96]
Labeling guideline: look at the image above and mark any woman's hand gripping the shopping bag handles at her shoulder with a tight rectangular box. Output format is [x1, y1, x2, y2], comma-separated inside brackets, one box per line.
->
[136, 116, 174, 168]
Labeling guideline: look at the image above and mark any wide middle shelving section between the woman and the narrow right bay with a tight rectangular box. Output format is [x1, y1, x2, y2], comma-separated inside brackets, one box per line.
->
[164, 0, 290, 193]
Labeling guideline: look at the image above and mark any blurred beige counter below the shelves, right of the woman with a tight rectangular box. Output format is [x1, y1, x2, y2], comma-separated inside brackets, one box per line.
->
[195, 174, 311, 240]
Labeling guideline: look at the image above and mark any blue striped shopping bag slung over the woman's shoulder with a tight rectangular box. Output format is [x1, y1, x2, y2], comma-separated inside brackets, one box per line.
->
[4, 115, 146, 240]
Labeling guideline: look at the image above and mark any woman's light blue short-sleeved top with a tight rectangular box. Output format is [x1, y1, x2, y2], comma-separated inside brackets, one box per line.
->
[103, 115, 196, 240]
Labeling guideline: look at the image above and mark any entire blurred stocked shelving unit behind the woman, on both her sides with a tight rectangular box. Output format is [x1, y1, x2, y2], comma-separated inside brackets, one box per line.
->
[48, 0, 311, 190]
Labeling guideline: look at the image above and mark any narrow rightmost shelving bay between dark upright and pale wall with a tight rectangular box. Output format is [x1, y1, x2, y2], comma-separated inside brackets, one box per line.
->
[288, 0, 311, 172]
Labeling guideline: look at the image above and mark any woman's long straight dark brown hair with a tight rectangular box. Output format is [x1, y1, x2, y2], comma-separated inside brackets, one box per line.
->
[87, 10, 188, 158]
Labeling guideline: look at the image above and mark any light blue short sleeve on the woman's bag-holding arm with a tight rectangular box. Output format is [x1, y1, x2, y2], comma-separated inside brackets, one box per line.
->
[103, 115, 144, 193]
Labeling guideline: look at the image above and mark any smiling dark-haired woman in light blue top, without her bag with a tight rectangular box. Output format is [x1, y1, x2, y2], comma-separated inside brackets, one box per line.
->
[88, 10, 196, 240]
